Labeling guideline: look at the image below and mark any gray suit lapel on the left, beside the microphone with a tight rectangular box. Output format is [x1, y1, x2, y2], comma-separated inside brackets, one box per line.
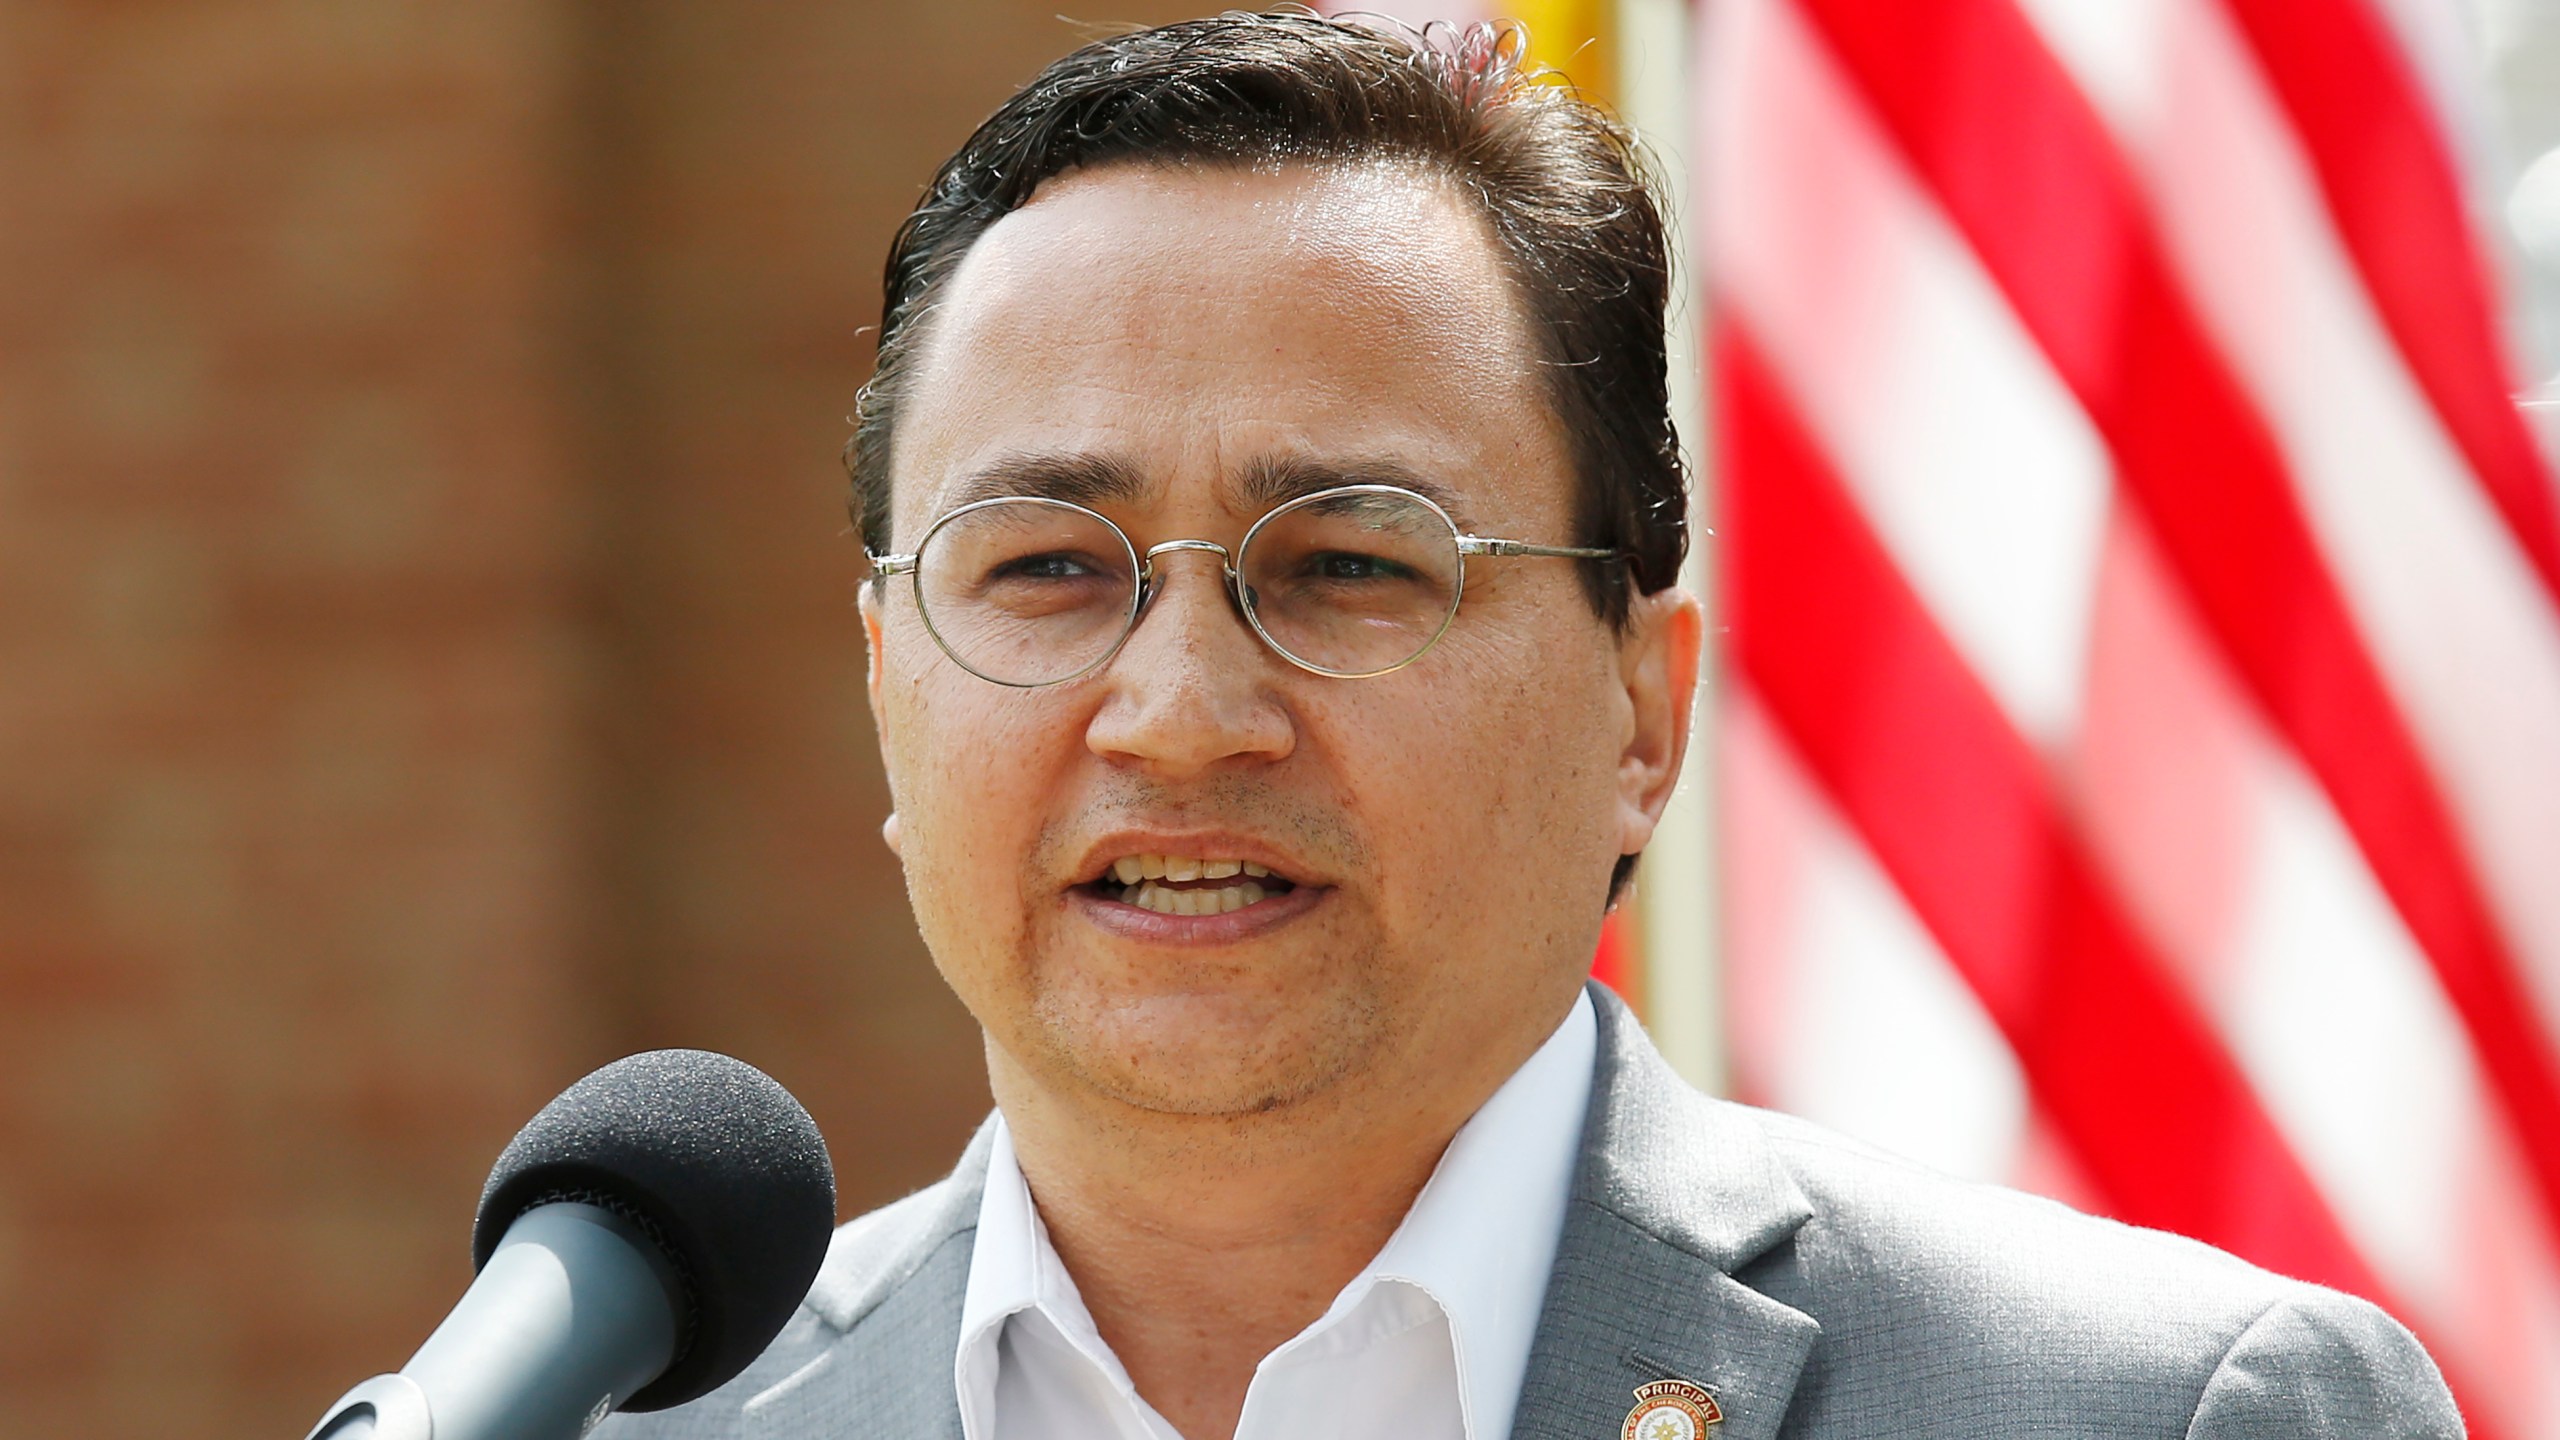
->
[740, 1125, 993, 1440]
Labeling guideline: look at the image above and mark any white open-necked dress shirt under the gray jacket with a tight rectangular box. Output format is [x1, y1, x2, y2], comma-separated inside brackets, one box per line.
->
[952, 994, 1595, 1440]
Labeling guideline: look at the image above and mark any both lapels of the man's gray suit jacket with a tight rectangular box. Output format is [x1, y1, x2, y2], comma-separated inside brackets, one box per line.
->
[742, 984, 1820, 1440]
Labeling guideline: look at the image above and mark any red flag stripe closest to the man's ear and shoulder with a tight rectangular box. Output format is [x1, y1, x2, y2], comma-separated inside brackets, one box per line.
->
[1715, 320, 2381, 1297]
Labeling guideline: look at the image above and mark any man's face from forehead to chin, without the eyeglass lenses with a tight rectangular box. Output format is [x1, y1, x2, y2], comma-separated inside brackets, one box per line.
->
[865, 167, 1695, 1115]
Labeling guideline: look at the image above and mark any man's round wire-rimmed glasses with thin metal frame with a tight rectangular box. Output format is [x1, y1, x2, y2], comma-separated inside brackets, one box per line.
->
[870, 484, 1623, 689]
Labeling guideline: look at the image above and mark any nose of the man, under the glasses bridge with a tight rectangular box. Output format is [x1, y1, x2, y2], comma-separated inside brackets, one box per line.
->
[1085, 541, 1298, 779]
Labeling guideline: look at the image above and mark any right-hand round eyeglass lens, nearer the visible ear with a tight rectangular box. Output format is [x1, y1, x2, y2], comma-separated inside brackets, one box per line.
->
[1236, 487, 1462, 676]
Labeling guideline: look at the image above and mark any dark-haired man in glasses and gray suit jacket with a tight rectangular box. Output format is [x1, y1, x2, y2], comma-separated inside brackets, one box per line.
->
[614, 15, 2460, 1440]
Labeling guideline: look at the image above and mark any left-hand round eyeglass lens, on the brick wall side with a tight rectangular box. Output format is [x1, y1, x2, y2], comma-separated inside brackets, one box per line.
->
[916, 497, 1137, 687]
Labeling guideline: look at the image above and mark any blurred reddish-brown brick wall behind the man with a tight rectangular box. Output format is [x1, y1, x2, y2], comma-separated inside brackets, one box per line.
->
[0, 0, 1180, 1440]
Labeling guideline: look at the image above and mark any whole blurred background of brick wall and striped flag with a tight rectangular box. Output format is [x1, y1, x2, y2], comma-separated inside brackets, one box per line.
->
[0, 0, 2560, 1440]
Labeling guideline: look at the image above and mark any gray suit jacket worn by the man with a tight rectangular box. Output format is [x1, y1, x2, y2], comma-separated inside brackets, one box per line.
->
[602, 986, 2463, 1440]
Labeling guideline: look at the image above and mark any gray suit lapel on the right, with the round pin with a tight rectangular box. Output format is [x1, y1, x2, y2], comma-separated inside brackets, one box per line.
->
[1513, 986, 1820, 1440]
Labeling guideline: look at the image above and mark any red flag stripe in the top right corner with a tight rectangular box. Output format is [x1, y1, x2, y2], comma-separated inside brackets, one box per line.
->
[2225, 0, 2560, 605]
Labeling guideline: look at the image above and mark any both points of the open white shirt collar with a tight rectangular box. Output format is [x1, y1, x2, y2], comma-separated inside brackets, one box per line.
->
[952, 992, 1597, 1440]
